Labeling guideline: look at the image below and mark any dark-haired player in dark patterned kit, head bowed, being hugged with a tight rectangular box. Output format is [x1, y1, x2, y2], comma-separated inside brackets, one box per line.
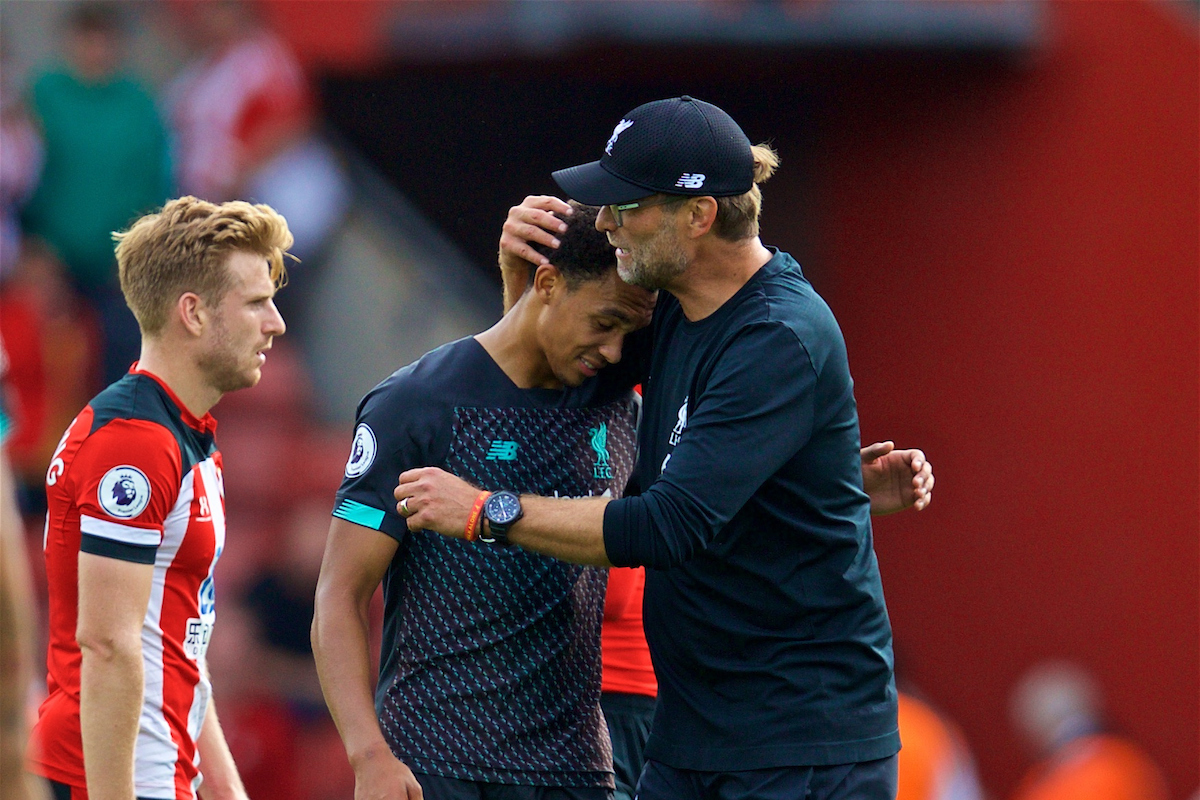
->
[313, 205, 928, 799]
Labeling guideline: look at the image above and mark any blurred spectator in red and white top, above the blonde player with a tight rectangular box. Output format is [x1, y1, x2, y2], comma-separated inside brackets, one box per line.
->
[168, 0, 349, 268]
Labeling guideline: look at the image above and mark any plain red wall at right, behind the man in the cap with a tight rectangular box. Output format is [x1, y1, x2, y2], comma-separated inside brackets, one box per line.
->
[811, 2, 1200, 798]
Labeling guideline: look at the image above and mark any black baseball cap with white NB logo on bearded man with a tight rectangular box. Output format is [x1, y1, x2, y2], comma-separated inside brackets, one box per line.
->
[553, 95, 754, 205]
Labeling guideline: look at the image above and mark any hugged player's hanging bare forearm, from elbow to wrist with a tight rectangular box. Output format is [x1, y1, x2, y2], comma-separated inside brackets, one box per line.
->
[312, 585, 391, 768]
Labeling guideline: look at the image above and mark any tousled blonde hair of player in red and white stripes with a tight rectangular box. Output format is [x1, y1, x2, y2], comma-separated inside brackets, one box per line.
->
[113, 196, 293, 336]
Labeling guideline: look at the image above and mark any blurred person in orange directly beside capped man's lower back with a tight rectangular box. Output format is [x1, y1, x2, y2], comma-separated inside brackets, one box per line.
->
[896, 691, 983, 800]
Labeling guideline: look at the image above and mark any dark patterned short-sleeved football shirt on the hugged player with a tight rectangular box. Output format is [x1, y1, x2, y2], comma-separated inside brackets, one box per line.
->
[335, 339, 637, 787]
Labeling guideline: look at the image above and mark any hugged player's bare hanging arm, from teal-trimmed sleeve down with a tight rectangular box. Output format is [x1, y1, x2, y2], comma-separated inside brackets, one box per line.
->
[312, 517, 422, 800]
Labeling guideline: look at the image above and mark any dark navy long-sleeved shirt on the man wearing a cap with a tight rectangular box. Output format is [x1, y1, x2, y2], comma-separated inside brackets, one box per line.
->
[604, 252, 900, 771]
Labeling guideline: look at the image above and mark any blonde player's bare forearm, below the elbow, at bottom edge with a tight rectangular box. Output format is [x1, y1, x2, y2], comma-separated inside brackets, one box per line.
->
[79, 638, 143, 800]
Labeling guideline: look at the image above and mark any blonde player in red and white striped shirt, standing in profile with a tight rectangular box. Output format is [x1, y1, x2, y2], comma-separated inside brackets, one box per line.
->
[31, 197, 292, 800]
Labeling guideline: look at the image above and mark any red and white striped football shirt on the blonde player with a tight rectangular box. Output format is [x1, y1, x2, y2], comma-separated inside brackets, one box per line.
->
[31, 365, 226, 800]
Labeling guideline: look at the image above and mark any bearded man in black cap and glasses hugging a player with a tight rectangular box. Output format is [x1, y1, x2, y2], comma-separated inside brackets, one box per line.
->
[395, 96, 902, 800]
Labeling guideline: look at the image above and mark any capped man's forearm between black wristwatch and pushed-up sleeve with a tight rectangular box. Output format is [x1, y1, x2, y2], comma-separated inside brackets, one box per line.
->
[509, 495, 612, 566]
